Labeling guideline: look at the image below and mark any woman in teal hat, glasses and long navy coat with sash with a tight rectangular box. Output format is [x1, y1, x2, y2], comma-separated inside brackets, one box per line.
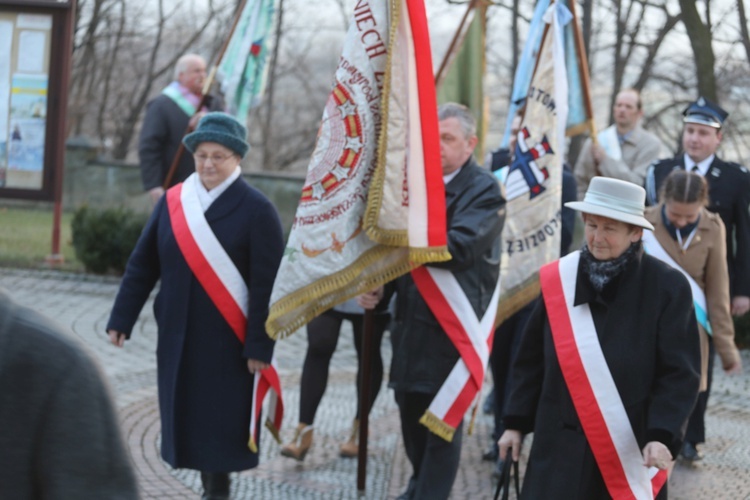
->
[107, 113, 284, 499]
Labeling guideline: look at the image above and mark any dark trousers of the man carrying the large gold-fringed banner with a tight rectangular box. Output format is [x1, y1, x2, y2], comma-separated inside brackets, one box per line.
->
[395, 391, 463, 500]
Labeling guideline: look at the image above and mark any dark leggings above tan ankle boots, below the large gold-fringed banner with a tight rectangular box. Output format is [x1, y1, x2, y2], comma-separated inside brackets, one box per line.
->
[299, 310, 390, 425]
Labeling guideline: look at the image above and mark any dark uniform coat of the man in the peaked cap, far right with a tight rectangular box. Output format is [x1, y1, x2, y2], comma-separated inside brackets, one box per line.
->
[646, 155, 750, 297]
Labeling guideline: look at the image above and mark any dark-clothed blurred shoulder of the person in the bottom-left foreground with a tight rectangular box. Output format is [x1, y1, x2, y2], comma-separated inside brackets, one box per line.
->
[0, 290, 138, 500]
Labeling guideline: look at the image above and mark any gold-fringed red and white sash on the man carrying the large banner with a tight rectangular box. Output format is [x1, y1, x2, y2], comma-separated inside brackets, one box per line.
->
[411, 266, 500, 441]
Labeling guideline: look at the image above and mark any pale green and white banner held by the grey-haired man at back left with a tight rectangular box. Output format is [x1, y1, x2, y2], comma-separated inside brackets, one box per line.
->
[217, 0, 275, 123]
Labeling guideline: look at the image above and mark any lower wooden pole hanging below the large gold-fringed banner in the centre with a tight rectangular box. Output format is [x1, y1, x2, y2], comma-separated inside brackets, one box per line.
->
[357, 309, 375, 494]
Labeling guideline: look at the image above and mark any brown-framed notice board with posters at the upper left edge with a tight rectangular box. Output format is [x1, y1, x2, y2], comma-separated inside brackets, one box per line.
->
[0, 0, 73, 200]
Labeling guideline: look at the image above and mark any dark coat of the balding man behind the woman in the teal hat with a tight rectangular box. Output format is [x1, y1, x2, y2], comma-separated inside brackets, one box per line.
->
[138, 94, 223, 191]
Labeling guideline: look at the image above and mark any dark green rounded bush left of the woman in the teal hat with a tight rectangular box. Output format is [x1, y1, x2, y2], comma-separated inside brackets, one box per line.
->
[71, 205, 146, 274]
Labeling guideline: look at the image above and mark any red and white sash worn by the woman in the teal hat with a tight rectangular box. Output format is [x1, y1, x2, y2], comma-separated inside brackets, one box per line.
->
[167, 178, 284, 453]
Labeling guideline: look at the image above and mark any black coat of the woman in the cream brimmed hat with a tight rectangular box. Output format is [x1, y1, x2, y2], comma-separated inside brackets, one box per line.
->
[503, 254, 700, 500]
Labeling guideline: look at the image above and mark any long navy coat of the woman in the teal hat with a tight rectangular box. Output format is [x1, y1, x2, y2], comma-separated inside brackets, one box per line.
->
[107, 178, 284, 472]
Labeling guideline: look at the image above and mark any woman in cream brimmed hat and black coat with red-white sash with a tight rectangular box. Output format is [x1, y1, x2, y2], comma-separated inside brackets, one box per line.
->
[498, 177, 700, 499]
